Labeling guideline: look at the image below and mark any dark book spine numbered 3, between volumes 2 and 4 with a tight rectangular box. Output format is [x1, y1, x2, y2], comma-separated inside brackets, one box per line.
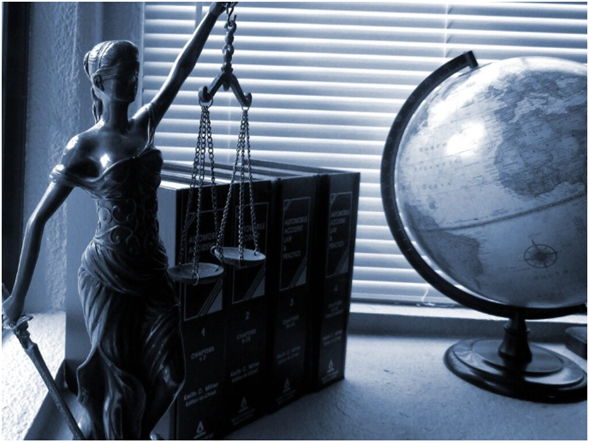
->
[268, 177, 315, 410]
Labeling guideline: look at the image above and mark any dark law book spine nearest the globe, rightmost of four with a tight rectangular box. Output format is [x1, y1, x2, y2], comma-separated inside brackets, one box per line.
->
[308, 173, 359, 389]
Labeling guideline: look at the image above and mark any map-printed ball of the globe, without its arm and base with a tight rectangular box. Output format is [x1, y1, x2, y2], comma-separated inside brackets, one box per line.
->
[395, 57, 587, 308]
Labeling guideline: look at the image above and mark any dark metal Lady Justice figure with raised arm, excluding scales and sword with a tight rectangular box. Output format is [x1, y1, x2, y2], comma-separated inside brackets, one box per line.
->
[2, 3, 228, 440]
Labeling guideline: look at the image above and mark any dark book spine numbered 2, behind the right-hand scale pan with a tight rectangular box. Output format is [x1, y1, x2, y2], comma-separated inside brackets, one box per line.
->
[224, 181, 271, 434]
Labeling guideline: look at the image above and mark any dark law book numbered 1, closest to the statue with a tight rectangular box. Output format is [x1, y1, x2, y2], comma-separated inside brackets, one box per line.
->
[156, 180, 227, 440]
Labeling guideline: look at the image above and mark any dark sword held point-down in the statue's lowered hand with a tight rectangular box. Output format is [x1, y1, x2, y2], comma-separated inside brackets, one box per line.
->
[2, 284, 85, 440]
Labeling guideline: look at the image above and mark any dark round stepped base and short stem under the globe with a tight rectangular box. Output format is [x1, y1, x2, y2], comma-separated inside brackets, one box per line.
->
[444, 314, 587, 403]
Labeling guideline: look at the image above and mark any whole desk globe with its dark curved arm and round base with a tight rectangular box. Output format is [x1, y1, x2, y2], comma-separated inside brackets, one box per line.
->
[381, 52, 587, 403]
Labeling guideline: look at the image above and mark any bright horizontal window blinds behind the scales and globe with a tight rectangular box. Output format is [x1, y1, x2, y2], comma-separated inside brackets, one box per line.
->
[143, 1, 587, 303]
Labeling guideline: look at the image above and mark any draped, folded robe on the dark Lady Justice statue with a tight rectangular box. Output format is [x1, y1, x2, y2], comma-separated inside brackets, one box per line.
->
[51, 143, 184, 439]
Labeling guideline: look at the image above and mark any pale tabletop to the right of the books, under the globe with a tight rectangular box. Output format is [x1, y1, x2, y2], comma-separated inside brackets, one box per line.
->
[229, 335, 587, 440]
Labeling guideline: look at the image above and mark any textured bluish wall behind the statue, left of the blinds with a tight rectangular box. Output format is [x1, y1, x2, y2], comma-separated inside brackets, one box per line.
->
[24, 2, 143, 312]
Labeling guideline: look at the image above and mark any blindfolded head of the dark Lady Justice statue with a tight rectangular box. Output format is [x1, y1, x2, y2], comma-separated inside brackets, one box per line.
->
[84, 40, 139, 121]
